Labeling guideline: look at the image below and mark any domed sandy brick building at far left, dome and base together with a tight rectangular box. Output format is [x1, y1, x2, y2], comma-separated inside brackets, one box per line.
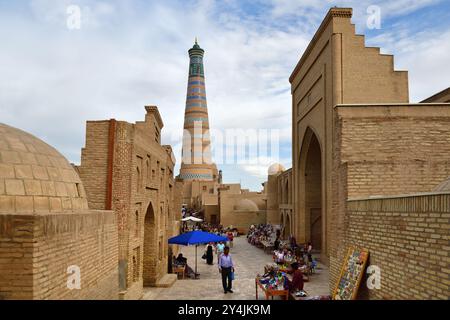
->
[0, 124, 119, 300]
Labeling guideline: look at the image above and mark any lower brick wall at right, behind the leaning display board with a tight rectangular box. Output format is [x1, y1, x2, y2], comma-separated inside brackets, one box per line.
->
[342, 193, 450, 300]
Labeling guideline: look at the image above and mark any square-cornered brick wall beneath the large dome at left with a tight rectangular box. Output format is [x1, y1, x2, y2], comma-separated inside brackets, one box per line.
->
[0, 211, 118, 300]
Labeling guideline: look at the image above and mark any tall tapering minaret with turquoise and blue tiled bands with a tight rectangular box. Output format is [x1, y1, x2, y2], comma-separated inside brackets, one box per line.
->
[179, 38, 215, 181]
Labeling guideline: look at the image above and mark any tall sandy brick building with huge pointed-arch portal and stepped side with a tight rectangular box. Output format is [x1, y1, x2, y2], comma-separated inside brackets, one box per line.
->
[289, 8, 450, 299]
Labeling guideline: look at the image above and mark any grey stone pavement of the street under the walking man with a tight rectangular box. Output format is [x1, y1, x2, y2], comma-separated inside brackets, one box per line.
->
[143, 236, 329, 300]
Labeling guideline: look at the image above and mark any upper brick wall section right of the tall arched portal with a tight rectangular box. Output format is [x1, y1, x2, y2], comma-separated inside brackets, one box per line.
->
[337, 105, 450, 198]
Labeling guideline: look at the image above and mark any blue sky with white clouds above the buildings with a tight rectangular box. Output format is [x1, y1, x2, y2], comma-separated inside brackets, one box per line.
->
[0, 0, 450, 190]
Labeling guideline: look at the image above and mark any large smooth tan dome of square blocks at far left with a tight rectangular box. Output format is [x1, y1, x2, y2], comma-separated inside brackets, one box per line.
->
[0, 123, 88, 213]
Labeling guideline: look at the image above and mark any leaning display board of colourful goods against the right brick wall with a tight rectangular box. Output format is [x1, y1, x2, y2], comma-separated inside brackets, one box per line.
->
[333, 246, 369, 300]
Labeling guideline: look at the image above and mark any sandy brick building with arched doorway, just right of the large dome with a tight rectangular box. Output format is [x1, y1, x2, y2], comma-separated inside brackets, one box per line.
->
[78, 106, 181, 299]
